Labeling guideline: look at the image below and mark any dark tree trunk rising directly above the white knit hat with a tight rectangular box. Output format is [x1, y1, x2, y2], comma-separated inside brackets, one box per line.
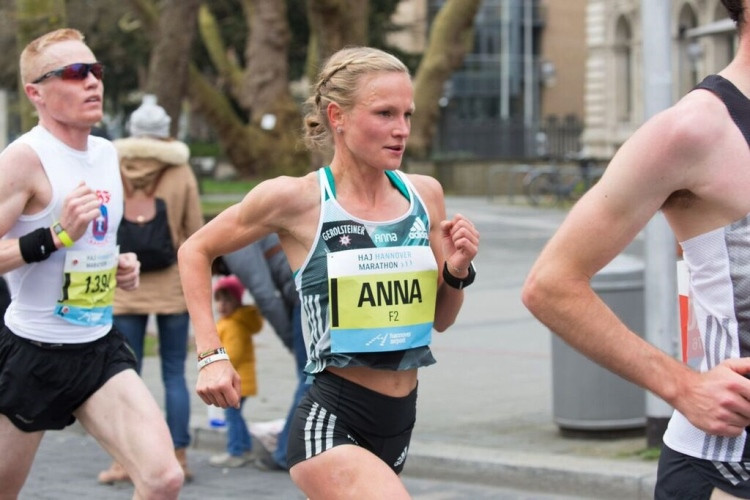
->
[146, 0, 201, 137]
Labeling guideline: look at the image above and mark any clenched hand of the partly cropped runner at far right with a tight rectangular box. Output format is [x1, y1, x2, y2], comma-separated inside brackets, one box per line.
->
[674, 358, 750, 437]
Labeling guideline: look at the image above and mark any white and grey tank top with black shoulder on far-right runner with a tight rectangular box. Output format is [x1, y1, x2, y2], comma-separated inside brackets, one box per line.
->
[664, 75, 750, 462]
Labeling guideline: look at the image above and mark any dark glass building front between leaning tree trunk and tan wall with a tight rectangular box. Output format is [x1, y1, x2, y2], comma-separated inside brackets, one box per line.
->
[427, 0, 545, 159]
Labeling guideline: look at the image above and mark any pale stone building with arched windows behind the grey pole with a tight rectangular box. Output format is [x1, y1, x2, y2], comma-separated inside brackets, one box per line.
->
[581, 0, 736, 159]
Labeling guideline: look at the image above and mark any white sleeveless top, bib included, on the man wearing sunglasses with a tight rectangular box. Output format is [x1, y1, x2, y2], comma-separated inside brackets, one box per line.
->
[5, 126, 123, 343]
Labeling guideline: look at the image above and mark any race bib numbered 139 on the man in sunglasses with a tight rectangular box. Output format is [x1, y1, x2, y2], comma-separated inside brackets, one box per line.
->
[55, 247, 119, 326]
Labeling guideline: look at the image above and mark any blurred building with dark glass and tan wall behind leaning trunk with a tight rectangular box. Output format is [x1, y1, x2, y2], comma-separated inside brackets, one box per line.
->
[389, 0, 587, 160]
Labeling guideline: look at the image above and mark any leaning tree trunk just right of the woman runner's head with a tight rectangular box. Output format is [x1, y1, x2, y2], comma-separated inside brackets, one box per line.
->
[408, 0, 482, 159]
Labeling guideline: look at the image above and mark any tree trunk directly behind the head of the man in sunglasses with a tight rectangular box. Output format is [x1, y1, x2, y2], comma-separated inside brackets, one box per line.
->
[16, 0, 67, 131]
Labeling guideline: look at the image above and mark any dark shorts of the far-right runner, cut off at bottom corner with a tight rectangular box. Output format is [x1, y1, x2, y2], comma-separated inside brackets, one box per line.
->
[654, 445, 750, 500]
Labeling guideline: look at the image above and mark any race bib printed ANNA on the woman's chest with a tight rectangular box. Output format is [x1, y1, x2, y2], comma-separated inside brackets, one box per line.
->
[327, 246, 437, 353]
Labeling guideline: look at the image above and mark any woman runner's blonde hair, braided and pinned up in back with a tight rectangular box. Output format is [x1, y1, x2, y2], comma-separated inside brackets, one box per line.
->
[304, 47, 409, 151]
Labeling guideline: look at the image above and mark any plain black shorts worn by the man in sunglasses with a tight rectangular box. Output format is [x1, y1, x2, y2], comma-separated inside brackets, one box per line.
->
[0, 327, 136, 432]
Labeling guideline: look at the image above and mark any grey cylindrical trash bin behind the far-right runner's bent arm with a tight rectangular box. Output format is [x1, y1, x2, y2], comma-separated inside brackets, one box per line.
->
[552, 254, 646, 431]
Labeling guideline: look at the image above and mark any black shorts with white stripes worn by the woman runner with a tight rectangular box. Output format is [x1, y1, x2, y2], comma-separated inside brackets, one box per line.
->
[287, 371, 417, 474]
